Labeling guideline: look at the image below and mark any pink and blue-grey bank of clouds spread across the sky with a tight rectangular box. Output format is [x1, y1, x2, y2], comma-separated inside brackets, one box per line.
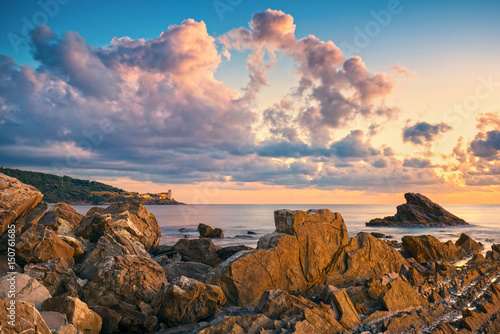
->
[0, 10, 478, 191]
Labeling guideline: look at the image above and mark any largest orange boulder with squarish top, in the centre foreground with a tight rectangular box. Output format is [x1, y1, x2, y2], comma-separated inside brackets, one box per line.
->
[207, 209, 349, 306]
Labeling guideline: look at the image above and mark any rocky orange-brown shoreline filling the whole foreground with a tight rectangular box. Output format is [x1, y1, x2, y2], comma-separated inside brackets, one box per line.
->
[0, 174, 500, 334]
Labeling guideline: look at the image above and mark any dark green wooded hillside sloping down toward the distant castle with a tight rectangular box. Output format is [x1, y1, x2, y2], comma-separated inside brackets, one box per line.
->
[0, 167, 131, 204]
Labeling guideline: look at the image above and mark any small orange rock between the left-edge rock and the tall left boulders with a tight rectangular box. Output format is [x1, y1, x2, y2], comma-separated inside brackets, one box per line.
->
[38, 203, 83, 237]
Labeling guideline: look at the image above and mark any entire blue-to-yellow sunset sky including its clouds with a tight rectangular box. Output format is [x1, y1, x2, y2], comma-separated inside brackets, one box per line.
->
[0, 0, 500, 204]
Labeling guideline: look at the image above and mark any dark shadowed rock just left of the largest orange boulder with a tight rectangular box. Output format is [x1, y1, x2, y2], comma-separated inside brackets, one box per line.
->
[174, 238, 222, 266]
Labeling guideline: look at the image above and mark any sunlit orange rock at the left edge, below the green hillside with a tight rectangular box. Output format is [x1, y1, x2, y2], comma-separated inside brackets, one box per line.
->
[0, 173, 43, 235]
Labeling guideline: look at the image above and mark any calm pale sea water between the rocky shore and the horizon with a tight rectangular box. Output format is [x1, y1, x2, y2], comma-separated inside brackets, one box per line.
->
[74, 204, 500, 249]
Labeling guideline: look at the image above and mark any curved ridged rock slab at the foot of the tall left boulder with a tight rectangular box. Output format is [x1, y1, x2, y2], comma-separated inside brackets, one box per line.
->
[76, 230, 150, 279]
